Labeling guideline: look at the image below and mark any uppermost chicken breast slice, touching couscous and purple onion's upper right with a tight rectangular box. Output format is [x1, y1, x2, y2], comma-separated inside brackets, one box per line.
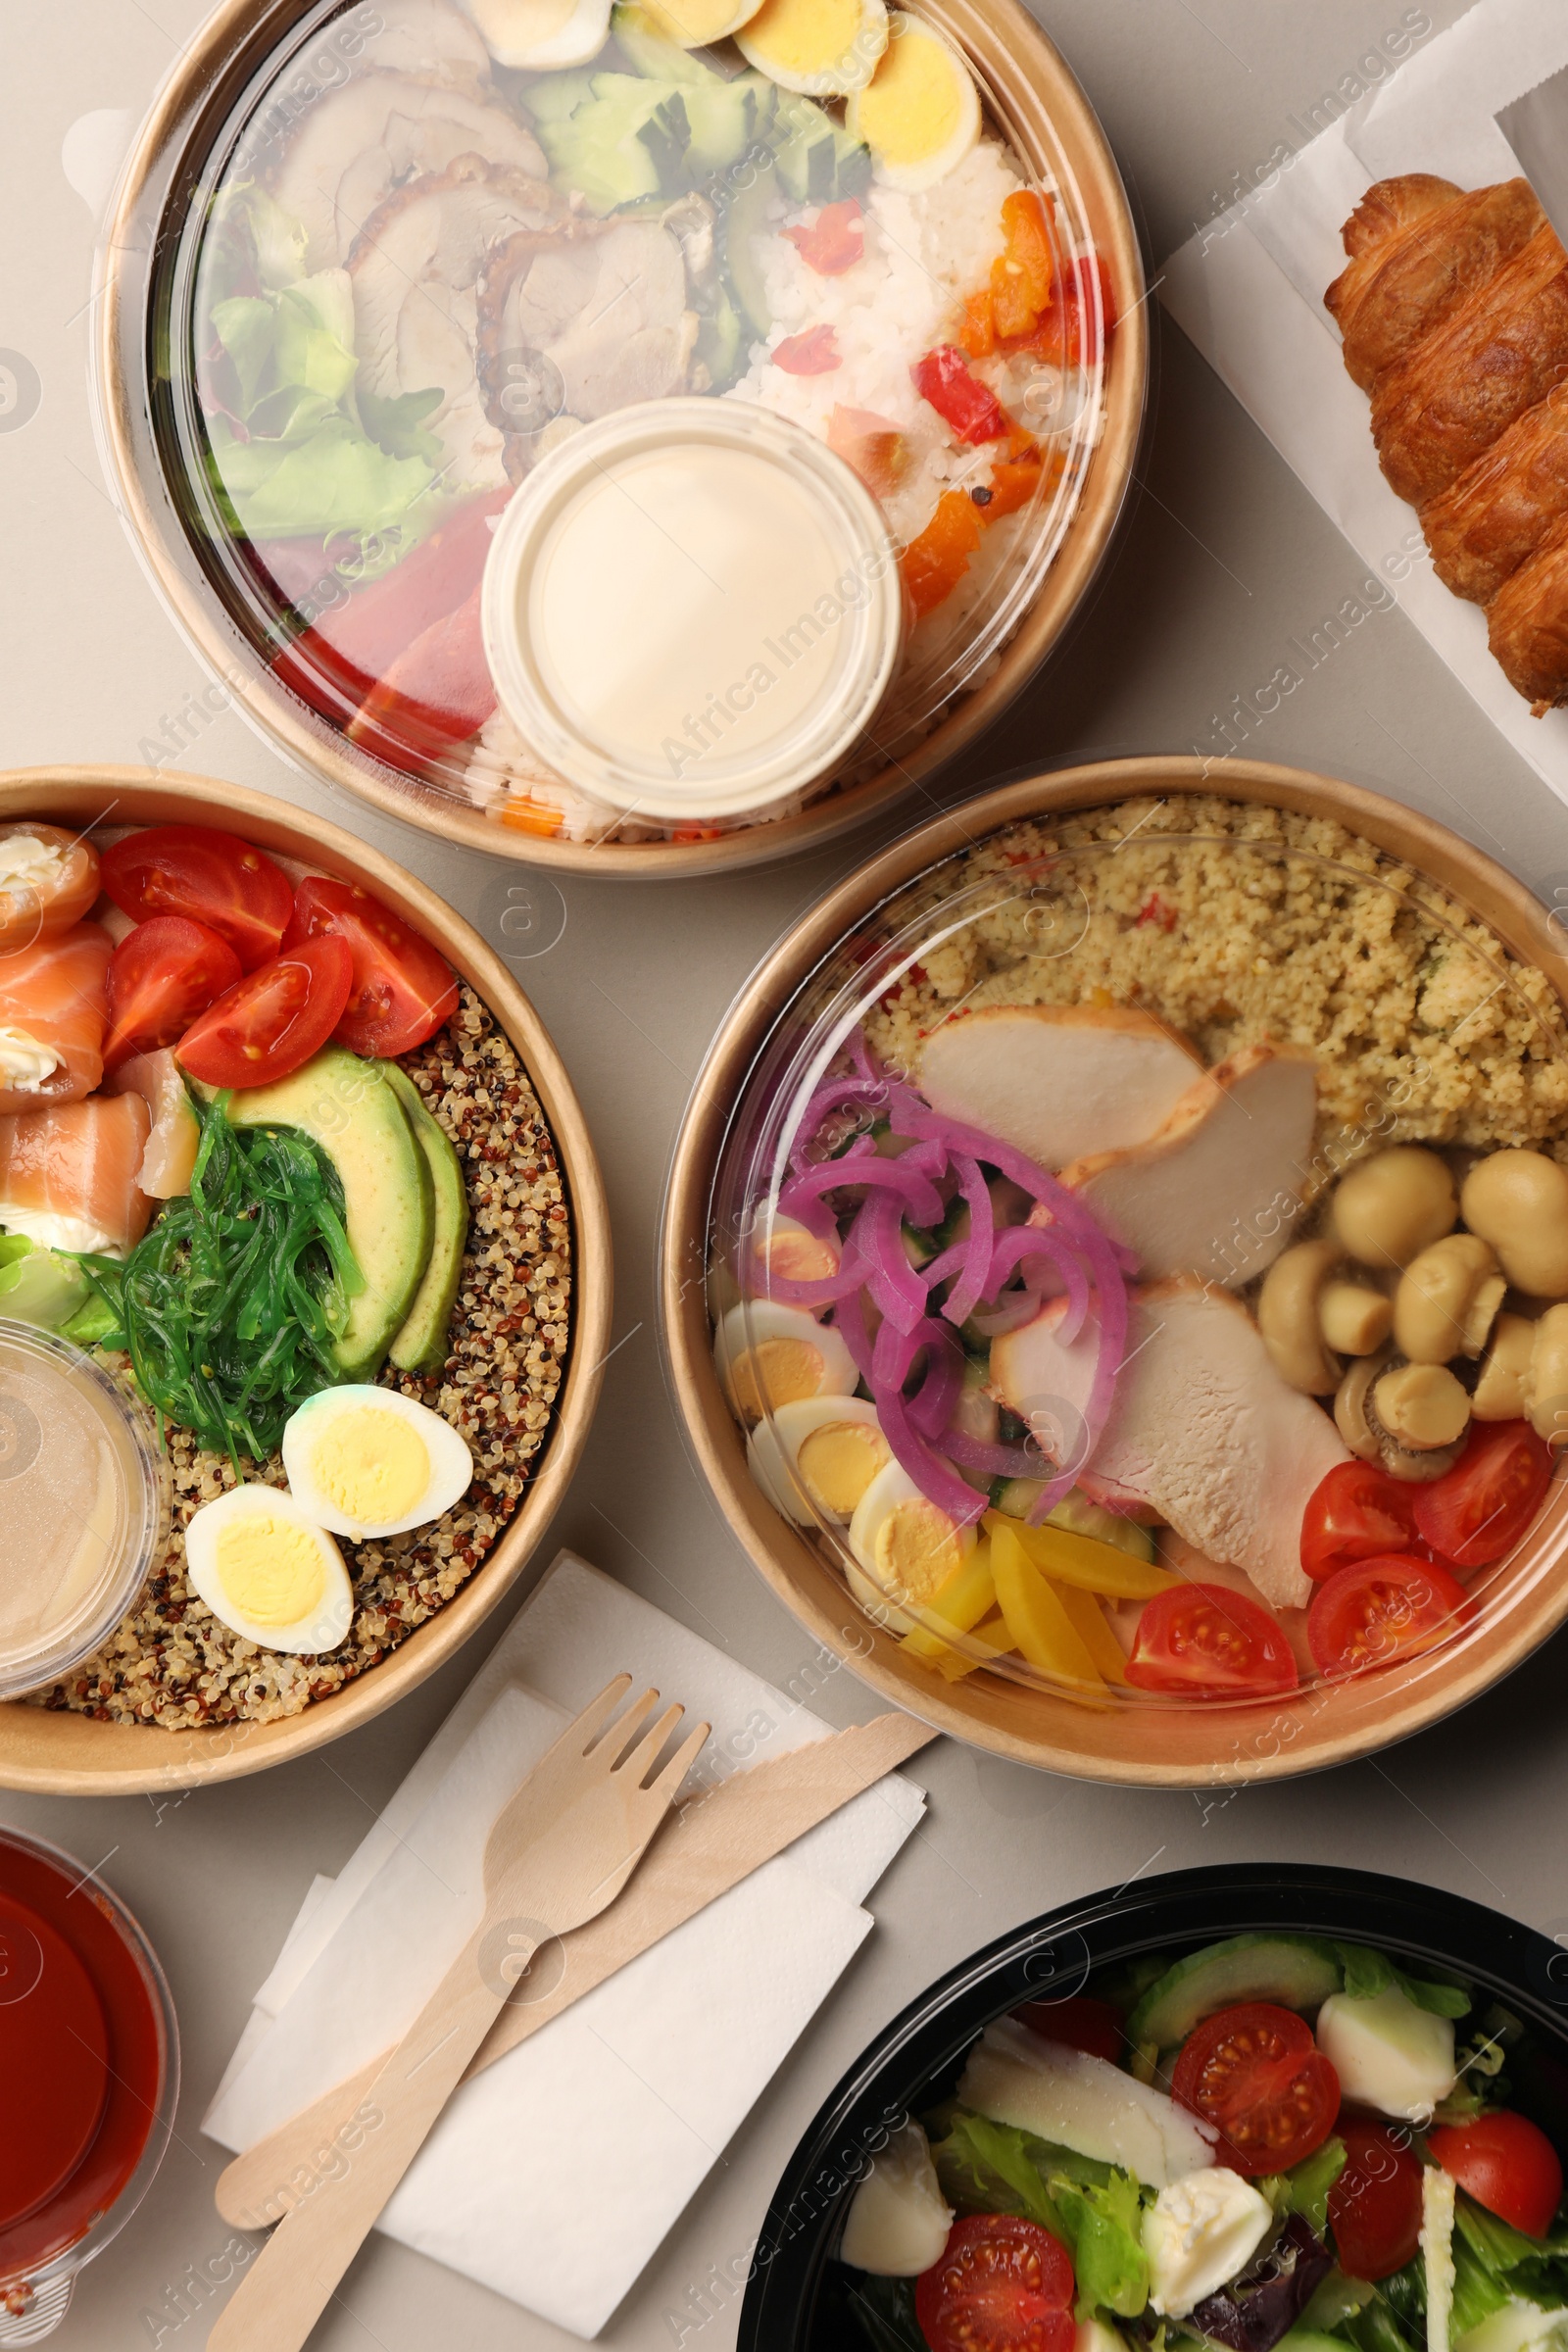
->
[917, 1004, 1203, 1169]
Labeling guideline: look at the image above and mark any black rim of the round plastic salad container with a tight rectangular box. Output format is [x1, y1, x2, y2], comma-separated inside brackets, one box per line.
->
[738, 1863, 1568, 2352]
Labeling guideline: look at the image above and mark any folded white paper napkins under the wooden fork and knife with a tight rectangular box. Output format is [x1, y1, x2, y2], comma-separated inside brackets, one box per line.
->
[202, 1552, 924, 2335]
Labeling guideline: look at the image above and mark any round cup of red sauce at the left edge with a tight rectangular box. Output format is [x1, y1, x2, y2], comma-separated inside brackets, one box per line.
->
[0, 1839, 167, 2281]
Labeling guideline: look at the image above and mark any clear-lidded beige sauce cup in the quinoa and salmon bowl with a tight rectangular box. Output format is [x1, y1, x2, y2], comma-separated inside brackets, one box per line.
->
[0, 1319, 170, 1698]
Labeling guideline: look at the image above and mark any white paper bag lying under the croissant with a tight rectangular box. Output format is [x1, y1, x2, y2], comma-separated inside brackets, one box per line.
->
[1159, 0, 1568, 800]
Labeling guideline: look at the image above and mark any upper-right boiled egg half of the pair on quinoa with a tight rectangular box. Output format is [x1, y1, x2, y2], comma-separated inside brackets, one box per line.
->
[282, 1383, 472, 1543]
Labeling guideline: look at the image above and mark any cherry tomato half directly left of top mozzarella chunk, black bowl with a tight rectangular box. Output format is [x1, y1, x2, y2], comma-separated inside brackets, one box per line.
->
[1171, 2001, 1340, 2180]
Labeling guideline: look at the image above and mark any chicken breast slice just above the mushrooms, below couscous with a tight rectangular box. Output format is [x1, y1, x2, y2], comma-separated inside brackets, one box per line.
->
[1062, 1045, 1316, 1289]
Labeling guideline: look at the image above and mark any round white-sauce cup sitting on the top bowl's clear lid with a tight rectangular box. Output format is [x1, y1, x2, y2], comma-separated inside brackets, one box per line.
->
[482, 398, 903, 821]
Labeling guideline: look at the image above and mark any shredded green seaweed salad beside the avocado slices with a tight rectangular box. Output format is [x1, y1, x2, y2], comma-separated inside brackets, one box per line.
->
[77, 1094, 365, 1475]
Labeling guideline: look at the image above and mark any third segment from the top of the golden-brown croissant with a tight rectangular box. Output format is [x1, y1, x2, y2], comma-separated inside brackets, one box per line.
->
[1420, 383, 1568, 605]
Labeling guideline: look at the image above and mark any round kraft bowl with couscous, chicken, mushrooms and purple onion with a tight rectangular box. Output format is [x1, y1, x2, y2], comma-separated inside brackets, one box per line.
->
[686, 780, 1568, 1778]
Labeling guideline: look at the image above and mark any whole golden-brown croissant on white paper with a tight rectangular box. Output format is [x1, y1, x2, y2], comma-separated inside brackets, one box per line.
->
[1324, 172, 1568, 717]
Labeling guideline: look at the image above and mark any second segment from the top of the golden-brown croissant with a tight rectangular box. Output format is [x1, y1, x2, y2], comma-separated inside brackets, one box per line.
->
[1373, 225, 1568, 506]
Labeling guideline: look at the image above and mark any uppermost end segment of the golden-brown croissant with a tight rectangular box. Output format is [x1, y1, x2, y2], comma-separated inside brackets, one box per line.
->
[1324, 172, 1543, 393]
